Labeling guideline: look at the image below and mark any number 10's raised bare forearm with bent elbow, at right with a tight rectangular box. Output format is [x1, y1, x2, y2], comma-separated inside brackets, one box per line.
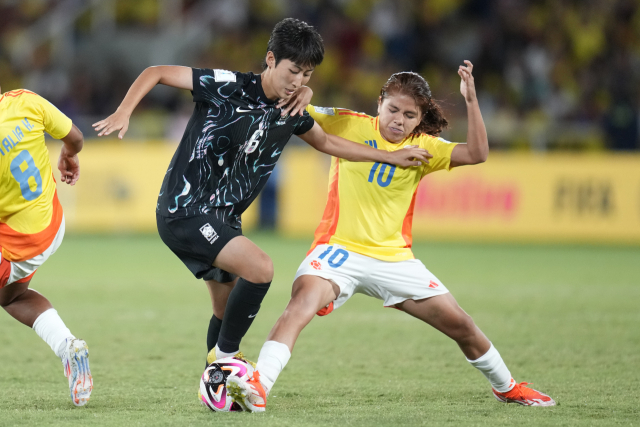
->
[451, 61, 489, 167]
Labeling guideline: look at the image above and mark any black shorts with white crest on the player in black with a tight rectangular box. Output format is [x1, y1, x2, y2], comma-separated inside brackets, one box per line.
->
[156, 214, 242, 283]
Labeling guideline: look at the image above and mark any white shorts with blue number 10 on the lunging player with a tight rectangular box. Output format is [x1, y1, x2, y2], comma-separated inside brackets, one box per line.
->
[295, 245, 449, 315]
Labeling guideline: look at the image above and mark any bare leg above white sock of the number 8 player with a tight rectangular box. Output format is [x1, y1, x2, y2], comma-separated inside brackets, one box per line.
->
[0, 281, 53, 328]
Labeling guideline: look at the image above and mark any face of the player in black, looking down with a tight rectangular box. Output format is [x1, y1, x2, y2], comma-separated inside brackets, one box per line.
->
[265, 52, 314, 99]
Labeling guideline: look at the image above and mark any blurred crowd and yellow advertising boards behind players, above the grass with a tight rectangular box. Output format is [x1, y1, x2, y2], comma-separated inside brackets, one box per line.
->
[0, 0, 640, 244]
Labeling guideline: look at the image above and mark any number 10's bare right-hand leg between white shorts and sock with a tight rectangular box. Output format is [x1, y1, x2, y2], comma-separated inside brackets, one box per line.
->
[397, 293, 491, 360]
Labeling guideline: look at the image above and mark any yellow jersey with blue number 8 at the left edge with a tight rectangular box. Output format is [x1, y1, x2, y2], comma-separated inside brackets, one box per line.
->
[0, 89, 72, 261]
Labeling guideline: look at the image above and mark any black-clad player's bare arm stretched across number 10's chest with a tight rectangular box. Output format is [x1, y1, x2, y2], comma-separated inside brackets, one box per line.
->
[300, 123, 433, 167]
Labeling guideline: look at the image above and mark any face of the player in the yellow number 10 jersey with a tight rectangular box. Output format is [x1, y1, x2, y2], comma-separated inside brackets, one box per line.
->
[378, 93, 422, 144]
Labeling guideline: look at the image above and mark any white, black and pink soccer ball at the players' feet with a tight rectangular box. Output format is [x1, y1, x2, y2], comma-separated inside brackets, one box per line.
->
[198, 357, 253, 412]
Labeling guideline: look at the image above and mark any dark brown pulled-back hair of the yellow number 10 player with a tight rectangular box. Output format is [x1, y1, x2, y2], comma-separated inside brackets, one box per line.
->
[380, 71, 449, 136]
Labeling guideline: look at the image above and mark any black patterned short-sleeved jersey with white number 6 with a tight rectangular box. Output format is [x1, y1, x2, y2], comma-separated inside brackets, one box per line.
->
[157, 68, 314, 227]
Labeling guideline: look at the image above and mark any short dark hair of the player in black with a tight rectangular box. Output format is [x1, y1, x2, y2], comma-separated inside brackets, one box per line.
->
[262, 18, 324, 69]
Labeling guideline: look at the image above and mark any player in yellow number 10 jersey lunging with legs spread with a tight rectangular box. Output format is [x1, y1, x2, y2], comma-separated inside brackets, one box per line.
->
[227, 61, 555, 411]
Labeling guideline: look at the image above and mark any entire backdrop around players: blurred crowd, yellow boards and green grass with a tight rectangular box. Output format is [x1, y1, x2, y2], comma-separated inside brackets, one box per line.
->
[0, 0, 640, 427]
